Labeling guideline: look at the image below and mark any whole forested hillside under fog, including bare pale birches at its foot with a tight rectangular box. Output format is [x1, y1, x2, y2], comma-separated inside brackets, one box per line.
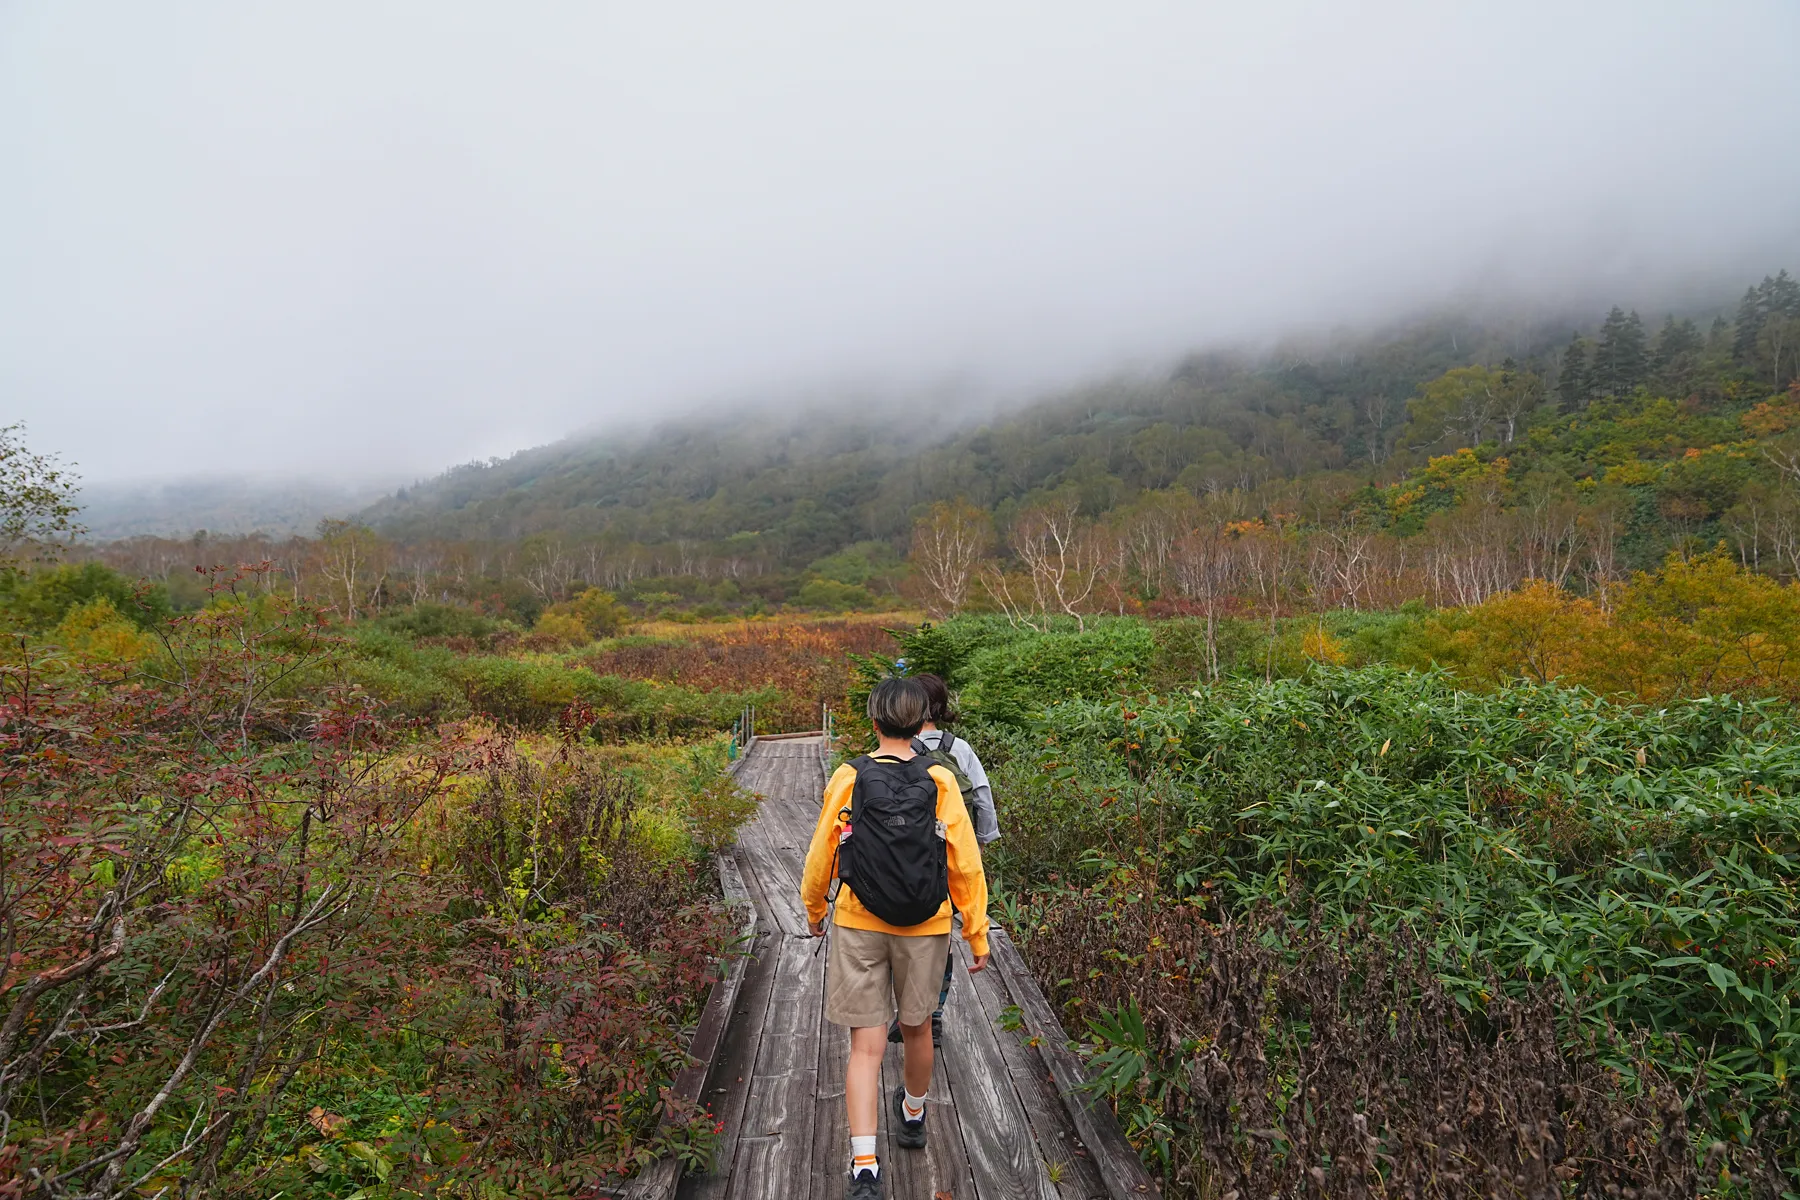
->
[70, 272, 1800, 626]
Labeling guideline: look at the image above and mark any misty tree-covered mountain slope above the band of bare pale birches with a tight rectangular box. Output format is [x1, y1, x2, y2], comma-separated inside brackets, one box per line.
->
[362, 272, 1800, 574]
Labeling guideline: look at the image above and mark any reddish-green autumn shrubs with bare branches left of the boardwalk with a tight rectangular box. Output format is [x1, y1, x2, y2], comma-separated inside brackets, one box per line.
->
[0, 572, 725, 1200]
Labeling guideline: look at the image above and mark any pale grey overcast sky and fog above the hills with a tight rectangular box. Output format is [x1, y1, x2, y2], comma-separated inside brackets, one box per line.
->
[0, 0, 1800, 480]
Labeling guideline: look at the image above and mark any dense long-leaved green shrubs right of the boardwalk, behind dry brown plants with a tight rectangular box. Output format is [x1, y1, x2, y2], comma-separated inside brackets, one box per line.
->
[986, 662, 1800, 1150]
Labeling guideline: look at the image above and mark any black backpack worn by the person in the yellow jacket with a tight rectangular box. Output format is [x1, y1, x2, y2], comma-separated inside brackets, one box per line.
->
[837, 754, 950, 928]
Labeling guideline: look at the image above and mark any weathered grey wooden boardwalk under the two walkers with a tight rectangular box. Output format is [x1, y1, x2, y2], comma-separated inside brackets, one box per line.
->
[677, 738, 1156, 1200]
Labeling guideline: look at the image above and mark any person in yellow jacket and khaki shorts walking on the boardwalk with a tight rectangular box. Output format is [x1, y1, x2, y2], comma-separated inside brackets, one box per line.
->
[801, 678, 988, 1200]
